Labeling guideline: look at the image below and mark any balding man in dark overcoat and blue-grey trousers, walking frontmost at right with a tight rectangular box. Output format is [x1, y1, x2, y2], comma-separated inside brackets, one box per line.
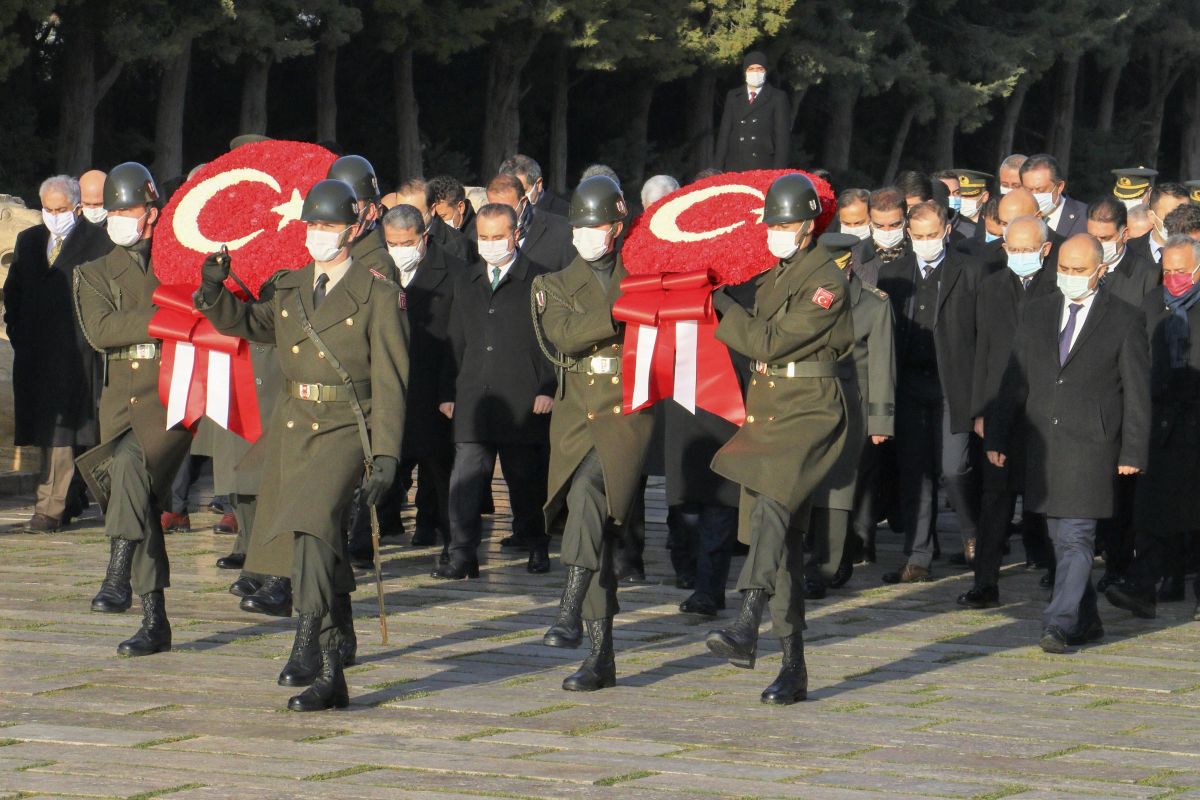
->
[985, 234, 1151, 652]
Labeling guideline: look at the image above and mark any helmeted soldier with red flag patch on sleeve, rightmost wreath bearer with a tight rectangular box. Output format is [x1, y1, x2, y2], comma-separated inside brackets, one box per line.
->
[706, 174, 859, 705]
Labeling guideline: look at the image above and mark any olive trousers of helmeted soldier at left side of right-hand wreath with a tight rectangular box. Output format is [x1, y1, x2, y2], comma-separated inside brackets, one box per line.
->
[562, 449, 620, 619]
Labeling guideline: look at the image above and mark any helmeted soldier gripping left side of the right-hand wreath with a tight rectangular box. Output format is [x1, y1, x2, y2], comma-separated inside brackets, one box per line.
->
[532, 175, 654, 692]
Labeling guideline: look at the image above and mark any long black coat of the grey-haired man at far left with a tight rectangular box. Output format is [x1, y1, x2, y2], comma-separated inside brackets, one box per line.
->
[4, 217, 113, 446]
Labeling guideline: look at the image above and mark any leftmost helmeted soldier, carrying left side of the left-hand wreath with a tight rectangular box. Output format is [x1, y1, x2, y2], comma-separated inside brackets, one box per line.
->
[73, 162, 192, 656]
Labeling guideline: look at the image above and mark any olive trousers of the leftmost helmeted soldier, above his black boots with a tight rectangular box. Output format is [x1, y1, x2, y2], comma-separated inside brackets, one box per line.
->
[104, 431, 170, 595]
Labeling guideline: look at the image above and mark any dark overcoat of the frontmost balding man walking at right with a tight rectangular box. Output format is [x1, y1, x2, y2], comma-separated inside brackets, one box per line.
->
[984, 291, 1151, 519]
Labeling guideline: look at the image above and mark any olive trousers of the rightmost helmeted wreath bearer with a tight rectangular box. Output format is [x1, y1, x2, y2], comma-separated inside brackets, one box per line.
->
[738, 487, 805, 638]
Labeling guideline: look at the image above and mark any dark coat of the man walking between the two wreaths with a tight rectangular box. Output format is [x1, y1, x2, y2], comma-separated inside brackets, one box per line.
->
[450, 253, 557, 445]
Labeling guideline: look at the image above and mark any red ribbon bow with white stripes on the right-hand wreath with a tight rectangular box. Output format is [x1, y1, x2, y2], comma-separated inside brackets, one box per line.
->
[612, 270, 745, 425]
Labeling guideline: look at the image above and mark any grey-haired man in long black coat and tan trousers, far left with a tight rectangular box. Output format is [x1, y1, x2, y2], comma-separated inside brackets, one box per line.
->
[4, 175, 113, 533]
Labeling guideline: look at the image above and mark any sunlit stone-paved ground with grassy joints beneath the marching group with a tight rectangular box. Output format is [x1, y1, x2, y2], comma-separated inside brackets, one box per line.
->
[0, 474, 1200, 800]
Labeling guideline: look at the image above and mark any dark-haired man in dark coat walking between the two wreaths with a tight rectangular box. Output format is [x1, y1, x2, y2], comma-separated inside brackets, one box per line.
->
[433, 203, 556, 579]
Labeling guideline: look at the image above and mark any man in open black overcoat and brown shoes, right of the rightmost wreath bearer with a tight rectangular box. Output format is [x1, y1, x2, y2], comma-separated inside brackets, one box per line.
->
[880, 203, 982, 583]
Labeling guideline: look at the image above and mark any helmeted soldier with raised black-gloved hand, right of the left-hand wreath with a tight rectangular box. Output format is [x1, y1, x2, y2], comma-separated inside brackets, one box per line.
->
[196, 180, 408, 711]
